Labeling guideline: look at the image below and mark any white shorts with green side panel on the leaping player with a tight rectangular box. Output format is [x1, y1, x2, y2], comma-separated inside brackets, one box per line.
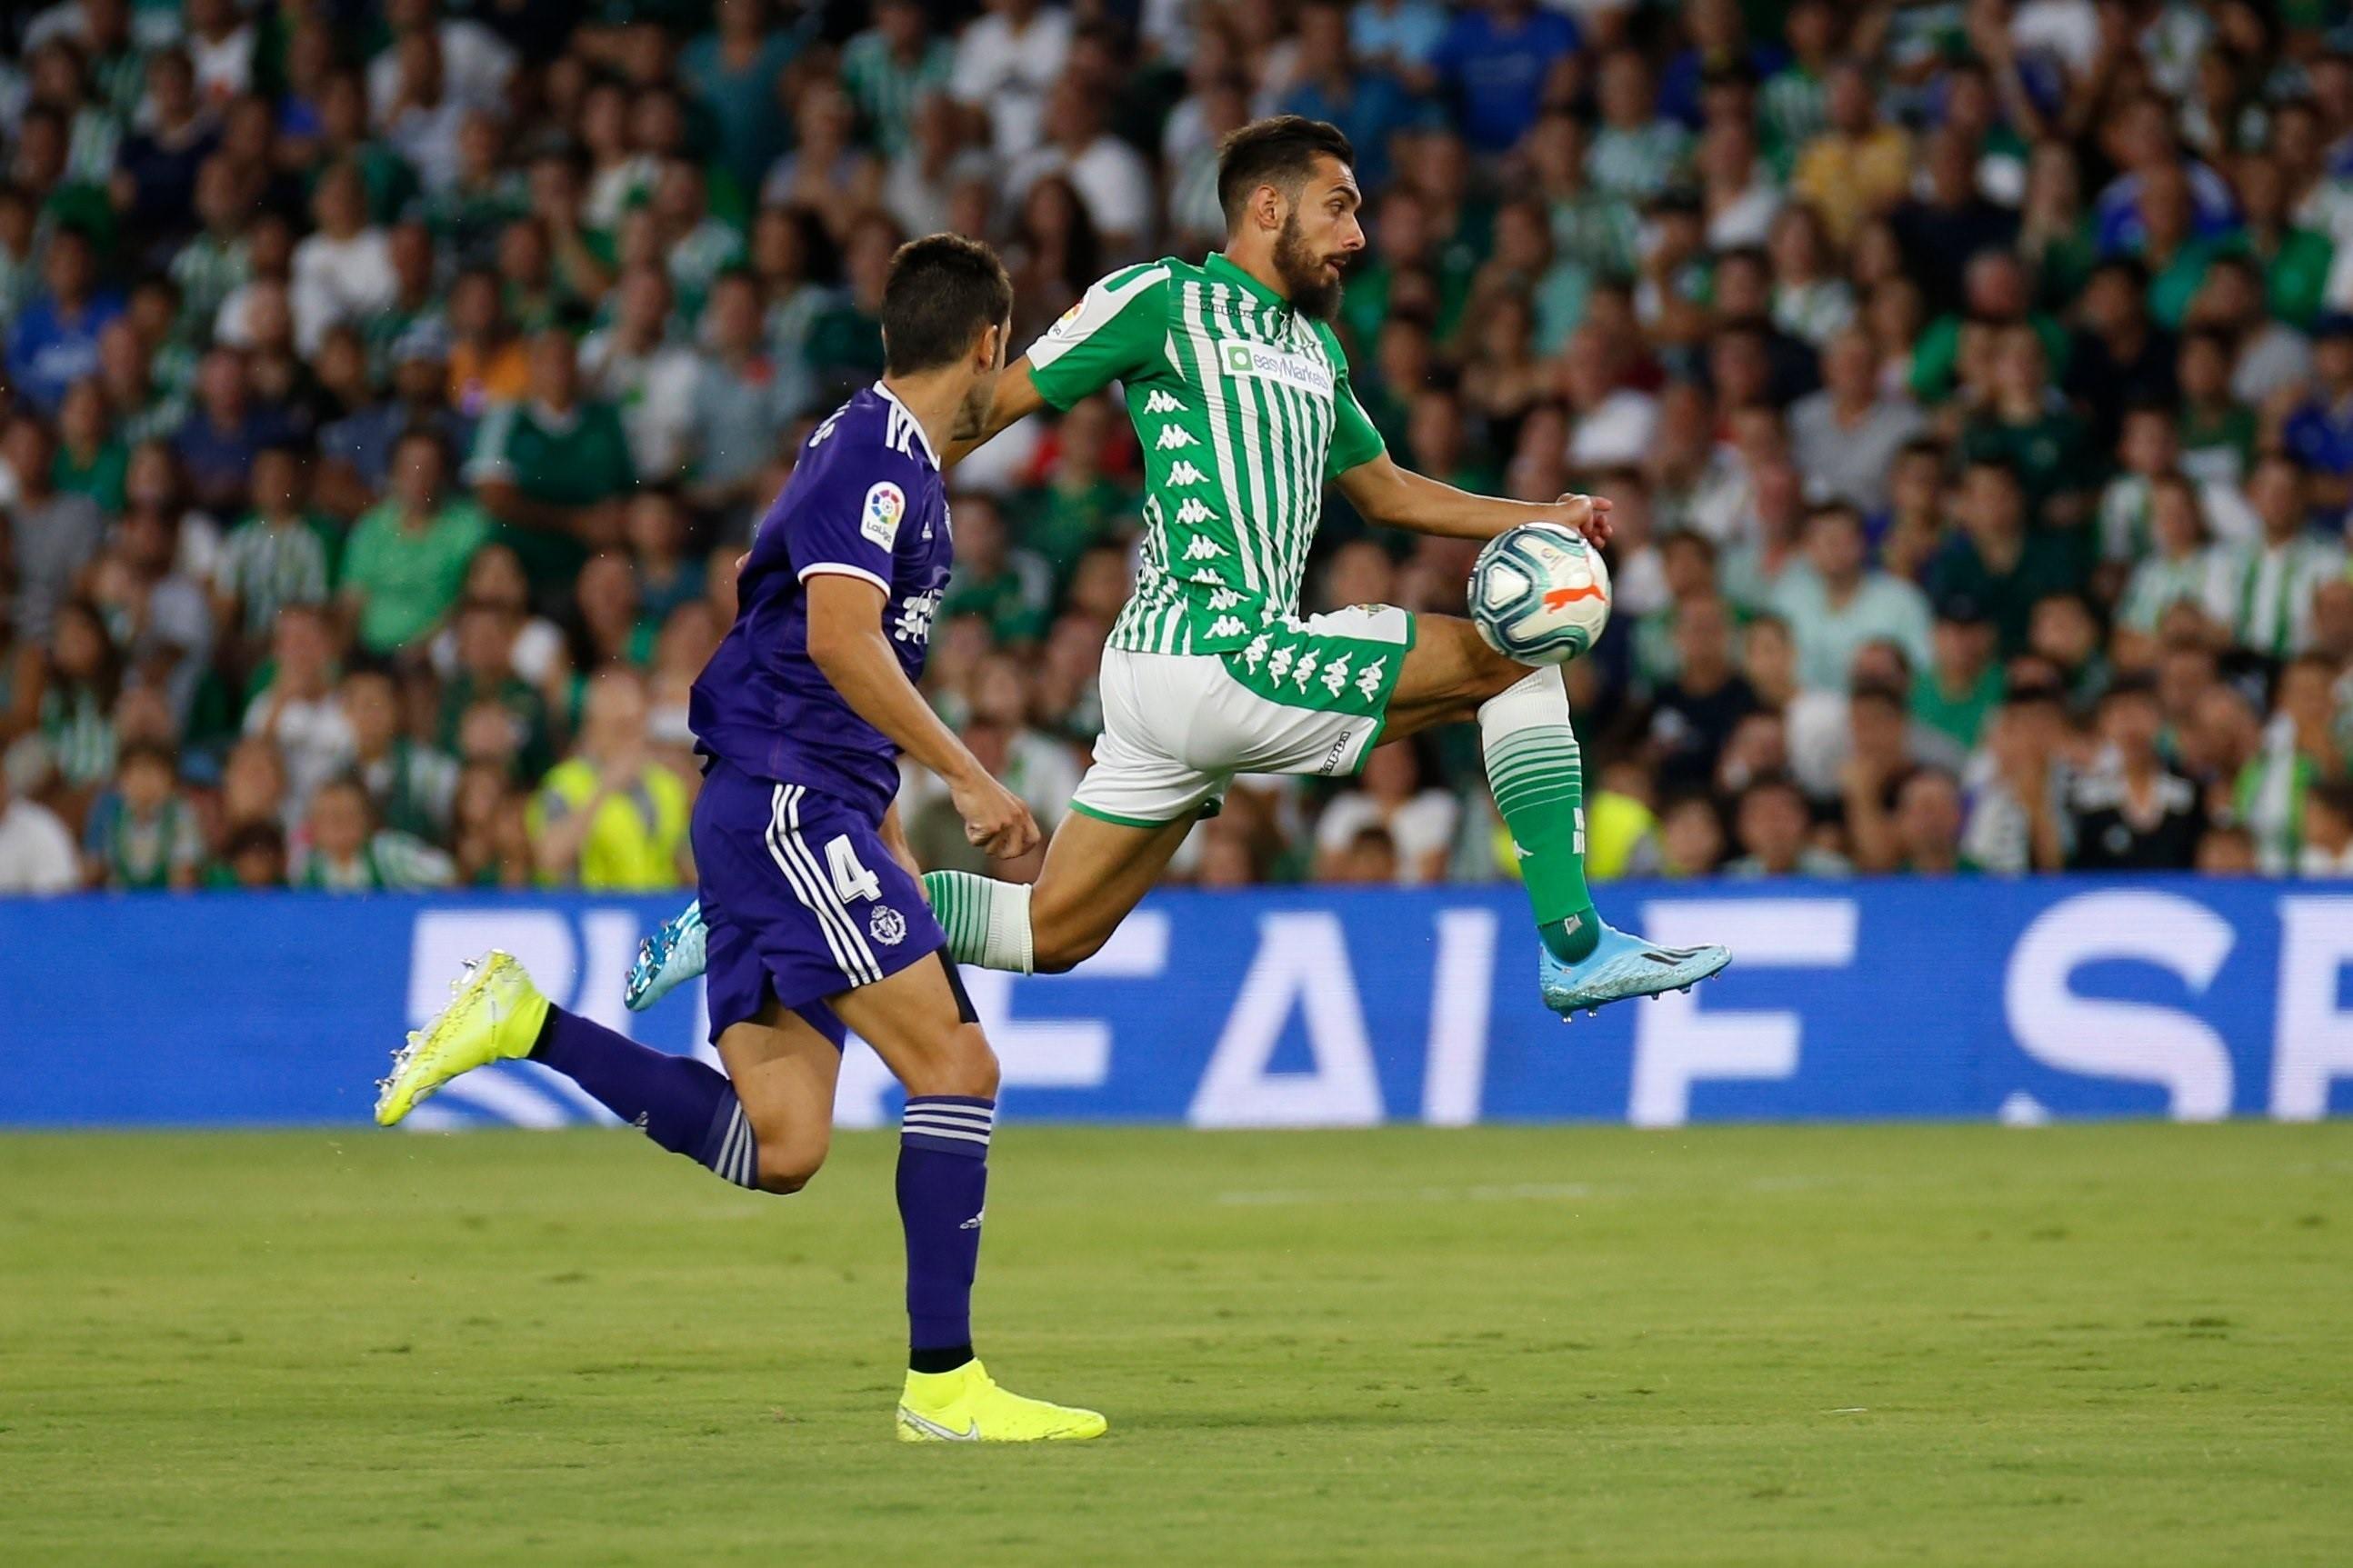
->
[1071, 604, 1414, 827]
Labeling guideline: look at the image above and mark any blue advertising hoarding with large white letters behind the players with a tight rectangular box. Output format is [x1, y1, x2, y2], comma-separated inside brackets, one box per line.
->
[0, 877, 2353, 1128]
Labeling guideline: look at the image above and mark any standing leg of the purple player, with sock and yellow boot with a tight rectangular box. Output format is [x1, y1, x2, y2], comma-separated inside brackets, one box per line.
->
[833, 954, 1106, 1443]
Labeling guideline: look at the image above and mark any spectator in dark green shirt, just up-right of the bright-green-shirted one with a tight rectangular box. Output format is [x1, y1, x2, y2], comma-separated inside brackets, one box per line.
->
[466, 329, 637, 597]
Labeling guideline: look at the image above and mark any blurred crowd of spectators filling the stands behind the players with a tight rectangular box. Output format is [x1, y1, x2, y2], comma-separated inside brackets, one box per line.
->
[0, 0, 2353, 891]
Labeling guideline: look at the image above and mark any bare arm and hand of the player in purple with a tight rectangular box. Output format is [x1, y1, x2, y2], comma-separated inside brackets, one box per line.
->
[803, 569, 1037, 861]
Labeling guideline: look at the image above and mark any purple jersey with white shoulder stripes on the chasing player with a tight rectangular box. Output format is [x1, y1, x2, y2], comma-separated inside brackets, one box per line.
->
[687, 384, 956, 821]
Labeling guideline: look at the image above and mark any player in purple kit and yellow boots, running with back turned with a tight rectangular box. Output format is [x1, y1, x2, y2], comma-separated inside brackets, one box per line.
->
[376, 235, 1106, 1441]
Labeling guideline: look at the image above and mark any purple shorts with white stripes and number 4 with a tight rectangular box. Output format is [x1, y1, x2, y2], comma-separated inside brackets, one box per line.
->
[694, 759, 948, 1046]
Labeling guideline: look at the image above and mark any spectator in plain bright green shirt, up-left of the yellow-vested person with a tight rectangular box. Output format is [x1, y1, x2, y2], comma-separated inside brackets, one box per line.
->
[341, 430, 489, 654]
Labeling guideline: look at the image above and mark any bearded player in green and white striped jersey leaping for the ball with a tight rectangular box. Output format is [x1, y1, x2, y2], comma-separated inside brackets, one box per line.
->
[631, 125, 1729, 1018]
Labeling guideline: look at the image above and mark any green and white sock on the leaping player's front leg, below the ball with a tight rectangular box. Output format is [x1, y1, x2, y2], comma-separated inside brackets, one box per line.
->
[1477, 670, 1602, 964]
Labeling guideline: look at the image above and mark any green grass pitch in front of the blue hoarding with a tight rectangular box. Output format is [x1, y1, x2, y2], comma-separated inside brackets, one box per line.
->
[0, 1114, 2353, 1568]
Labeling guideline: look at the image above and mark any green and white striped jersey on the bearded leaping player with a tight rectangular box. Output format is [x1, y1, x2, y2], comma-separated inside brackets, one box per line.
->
[1028, 256, 1381, 654]
